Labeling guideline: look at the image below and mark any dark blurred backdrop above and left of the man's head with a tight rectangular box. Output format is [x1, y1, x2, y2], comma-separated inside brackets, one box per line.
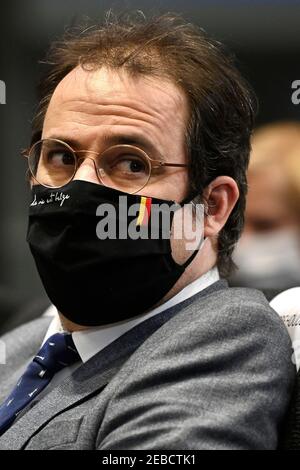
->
[0, 0, 300, 326]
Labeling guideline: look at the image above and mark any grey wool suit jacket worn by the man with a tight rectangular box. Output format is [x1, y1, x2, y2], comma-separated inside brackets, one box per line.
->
[0, 281, 295, 450]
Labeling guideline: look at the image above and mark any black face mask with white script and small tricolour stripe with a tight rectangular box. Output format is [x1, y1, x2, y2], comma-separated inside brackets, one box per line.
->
[27, 180, 198, 326]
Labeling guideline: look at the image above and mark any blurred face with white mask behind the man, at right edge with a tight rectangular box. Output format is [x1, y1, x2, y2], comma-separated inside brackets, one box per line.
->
[233, 123, 300, 289]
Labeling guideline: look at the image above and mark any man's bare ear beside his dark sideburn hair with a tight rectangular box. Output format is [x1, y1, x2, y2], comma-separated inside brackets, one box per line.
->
[204, 176, 239, 237]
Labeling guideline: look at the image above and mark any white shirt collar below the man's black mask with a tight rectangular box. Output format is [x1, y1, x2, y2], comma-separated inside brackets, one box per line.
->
[43, 267, 220, 362]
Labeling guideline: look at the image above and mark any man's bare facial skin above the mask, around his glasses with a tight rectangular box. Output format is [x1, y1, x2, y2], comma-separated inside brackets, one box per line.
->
[42, 67, 188, 202]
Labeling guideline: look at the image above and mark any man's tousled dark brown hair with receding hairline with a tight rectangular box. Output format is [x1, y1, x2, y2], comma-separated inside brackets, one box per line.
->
[32, 11, 256, 277]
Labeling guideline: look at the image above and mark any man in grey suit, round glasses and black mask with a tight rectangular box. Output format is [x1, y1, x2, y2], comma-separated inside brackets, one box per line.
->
[0, 15, 294, 450]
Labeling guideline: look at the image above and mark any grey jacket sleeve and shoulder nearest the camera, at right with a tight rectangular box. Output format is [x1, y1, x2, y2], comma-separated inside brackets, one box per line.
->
[98, 288, 295, 450]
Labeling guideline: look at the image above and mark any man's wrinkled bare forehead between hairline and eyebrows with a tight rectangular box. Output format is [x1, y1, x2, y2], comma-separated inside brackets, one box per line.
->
[45, 66, 188, 132]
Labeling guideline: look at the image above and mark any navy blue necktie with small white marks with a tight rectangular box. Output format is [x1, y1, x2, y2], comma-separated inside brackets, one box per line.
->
[0, 333, 80, 436]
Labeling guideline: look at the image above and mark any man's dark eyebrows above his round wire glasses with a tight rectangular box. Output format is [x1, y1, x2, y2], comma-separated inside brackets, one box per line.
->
[46, 134, 165, 160]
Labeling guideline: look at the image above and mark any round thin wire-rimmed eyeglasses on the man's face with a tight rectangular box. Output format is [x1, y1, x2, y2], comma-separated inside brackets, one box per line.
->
[23, 139, 188, 194]
